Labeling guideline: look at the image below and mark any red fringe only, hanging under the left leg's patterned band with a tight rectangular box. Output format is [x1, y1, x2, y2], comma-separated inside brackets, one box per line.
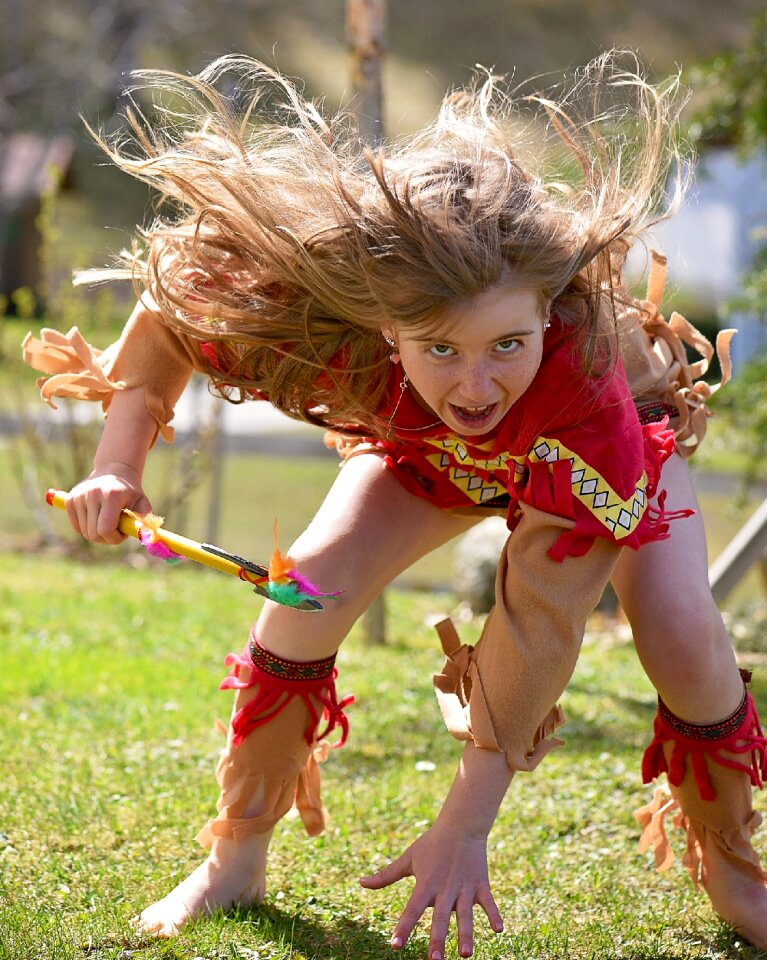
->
[219, 647, 354, 749]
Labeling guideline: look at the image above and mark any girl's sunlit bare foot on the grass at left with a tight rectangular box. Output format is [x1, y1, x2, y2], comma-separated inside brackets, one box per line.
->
[132, 830, 272, 938]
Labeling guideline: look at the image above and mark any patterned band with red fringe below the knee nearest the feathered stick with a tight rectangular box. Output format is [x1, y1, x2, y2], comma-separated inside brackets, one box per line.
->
[221, 632, 354, 747]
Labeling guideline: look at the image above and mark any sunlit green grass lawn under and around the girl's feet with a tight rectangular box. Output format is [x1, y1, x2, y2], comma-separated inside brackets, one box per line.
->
[0, 555, 767, 960]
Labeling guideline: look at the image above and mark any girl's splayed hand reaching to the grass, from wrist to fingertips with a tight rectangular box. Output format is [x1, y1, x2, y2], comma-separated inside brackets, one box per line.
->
[360, 819, 503, 960]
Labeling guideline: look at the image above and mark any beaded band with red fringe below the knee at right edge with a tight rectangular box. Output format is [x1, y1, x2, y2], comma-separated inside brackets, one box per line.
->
[642, 670, 767, 801]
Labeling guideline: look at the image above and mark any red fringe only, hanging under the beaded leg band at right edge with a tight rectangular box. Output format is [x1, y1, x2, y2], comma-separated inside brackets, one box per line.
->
[642, 693, 767, 800]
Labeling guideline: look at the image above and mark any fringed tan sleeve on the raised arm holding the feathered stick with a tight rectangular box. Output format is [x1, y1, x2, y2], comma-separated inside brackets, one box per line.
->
[22, 303, 202, 441]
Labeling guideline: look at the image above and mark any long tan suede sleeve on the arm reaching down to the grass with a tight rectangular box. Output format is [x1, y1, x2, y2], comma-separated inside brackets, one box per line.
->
[435, 504, 620, 771]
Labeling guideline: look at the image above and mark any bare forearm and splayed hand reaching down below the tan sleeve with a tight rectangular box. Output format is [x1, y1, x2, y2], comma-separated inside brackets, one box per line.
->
[360, 742, 513, 960]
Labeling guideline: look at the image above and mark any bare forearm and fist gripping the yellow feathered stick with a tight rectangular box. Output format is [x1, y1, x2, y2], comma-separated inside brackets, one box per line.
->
[67, 388, 157, 544]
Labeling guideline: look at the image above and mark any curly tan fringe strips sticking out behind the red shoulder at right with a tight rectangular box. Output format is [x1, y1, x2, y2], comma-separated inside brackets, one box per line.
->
[618, 250, 736, 457]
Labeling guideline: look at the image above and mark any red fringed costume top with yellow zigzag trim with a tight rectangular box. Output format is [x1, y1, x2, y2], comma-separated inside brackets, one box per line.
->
[371, 320, 674, 561]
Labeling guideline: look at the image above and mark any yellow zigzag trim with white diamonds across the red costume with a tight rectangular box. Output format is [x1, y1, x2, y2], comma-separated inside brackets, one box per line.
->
[427, 437, 648, 540]
